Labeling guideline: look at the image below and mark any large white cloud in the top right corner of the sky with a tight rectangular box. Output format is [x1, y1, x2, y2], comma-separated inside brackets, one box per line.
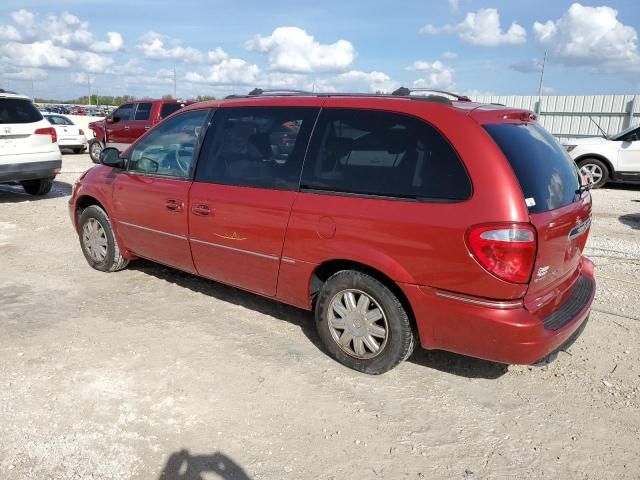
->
[533, 3, 640, 72]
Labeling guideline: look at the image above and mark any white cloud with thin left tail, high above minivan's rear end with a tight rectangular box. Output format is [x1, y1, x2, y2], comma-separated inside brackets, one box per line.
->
[419, 8, 527, 47]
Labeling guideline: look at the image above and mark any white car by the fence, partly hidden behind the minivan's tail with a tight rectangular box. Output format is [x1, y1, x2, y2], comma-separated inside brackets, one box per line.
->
[564, 125, 640, 188]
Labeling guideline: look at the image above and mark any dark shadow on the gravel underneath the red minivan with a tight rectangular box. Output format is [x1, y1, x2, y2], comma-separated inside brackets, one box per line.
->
[129, 260, 507, 380]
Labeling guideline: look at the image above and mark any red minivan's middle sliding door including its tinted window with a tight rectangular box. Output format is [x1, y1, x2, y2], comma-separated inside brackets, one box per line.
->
[189, 107, 318, 296]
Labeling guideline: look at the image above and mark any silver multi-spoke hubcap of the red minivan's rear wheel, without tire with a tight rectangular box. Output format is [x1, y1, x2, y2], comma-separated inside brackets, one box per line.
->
[328, 289, 389, 359]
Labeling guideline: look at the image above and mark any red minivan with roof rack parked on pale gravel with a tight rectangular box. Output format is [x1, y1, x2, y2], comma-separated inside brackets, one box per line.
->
[69, 89, 595, 374]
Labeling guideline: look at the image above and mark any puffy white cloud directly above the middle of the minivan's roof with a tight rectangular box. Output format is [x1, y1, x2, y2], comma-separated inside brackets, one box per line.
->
[245, 27, 355, 73]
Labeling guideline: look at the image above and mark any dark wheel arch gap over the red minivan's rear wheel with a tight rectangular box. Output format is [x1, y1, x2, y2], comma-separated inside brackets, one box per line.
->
[309, 259, 416, 327]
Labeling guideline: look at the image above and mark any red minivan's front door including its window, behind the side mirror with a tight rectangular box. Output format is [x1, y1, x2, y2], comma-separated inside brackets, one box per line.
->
[113, 110, 209, 273]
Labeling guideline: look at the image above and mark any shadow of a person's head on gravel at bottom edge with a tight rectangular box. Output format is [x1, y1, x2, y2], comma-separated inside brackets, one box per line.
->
[158, 450, 251, 480]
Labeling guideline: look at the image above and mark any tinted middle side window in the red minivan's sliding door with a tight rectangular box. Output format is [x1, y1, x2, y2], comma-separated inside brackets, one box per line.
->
[196, 107, 318, 190]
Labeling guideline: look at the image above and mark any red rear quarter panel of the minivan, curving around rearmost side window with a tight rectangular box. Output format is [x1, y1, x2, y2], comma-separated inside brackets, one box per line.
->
[283, 98, 529, 306]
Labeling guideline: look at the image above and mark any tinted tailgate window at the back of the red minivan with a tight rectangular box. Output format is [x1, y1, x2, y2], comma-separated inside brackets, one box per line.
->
[484, 123, 580, 213]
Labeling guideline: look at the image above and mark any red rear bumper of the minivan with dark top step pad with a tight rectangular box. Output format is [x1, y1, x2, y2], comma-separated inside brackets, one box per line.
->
[400, 257, 595, 364]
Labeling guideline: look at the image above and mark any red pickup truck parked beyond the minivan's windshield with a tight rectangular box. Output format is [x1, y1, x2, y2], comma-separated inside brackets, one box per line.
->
[89, 99, 195, 163]
